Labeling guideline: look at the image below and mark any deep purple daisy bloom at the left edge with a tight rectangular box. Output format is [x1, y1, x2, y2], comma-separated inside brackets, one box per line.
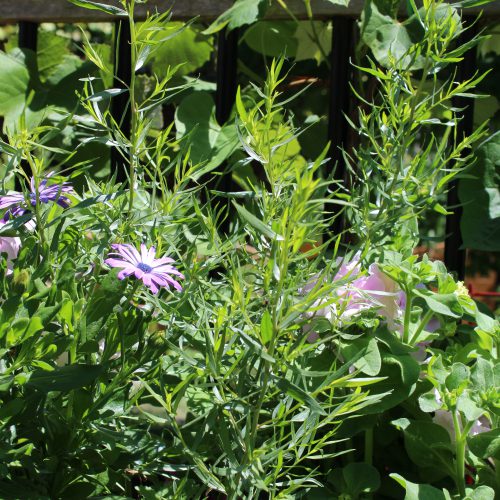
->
[0, 174, 73, 221]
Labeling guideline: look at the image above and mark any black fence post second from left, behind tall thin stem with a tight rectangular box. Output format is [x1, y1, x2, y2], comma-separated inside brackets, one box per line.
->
[111, 20, 132, 182]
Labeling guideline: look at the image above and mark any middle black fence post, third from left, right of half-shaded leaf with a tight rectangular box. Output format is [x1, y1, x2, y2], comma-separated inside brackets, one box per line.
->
[214, 29, 239, 233]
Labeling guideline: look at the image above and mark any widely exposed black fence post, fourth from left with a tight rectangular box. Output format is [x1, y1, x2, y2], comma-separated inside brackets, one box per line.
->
[328, 16, 356, 240]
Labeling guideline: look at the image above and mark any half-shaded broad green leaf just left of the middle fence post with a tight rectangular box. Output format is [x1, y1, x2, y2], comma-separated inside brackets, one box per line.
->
[175, 92, 239, 171]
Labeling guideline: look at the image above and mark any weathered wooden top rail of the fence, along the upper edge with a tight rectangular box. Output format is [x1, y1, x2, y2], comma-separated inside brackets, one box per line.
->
[0, 0, 500, 24]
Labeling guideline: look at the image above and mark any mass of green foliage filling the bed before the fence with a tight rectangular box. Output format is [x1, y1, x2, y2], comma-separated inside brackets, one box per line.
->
[0, 0, 500, 500]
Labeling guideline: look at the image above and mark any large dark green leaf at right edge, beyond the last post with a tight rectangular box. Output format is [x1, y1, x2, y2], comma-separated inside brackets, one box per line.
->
[458, 132, 500, 252]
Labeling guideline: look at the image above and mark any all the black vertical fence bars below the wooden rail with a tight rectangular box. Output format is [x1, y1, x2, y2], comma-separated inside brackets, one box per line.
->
[8, 2, 499, 279]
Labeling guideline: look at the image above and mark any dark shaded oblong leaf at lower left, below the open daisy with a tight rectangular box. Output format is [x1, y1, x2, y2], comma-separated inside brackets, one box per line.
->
[27, 365, 103, 392]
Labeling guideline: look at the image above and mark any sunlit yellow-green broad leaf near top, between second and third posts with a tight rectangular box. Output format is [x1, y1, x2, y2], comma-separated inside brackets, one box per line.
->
[151, 22, 214, 77]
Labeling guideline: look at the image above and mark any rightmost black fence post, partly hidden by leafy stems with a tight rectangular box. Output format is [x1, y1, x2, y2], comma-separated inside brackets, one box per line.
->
[444, 16, 477, 280]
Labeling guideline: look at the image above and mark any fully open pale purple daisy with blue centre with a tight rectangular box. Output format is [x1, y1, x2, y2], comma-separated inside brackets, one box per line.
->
[104, 243, 184, 294]
